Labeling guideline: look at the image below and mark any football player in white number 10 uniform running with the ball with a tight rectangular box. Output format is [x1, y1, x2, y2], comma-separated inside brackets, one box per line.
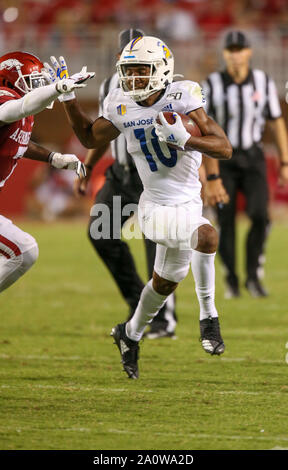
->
[46, 36, 232, 379]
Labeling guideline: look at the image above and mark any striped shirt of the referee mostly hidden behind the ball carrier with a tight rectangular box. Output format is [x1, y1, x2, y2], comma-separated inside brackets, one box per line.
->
[99, 73, 135, 169]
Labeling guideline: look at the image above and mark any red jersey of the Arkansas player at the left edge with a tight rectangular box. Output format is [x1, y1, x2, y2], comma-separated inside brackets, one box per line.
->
[0, 87, 34, 190]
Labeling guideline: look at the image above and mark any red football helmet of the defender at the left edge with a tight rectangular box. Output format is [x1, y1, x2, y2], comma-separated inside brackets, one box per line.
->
[0, 51, 47, 96]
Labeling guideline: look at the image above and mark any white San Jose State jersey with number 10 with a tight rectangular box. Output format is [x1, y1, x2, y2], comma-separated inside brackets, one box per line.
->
[103, 80, 205, 206]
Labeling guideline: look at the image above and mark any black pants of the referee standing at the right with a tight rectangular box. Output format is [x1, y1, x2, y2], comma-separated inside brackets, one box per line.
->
[218, 145, 269, 285]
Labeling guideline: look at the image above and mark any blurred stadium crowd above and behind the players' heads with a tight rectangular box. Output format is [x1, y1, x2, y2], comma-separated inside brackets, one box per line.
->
[0, 0, 288, 99]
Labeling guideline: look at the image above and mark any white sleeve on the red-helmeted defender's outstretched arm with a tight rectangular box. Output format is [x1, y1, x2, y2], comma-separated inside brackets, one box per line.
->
[0, 83, 59, 124]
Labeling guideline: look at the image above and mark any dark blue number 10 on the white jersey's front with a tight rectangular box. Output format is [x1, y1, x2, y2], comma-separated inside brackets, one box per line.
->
[134, 128, 177, 171]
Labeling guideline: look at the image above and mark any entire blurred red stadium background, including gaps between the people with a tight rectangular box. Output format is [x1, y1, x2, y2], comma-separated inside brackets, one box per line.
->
[0, 0, 288, 216]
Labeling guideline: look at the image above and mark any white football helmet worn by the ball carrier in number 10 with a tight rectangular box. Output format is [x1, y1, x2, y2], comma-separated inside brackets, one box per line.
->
[116, 36, 174, 101]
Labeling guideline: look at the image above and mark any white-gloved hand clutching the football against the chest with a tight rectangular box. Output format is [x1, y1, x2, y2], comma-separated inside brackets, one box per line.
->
[155, 113, 191, 150]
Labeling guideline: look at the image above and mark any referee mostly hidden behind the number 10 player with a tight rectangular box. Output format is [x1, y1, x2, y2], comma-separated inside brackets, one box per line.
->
[75, 29, 177, 339]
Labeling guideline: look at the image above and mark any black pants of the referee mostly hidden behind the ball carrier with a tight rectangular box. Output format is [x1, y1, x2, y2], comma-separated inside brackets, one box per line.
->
[88, 162, 176, 329]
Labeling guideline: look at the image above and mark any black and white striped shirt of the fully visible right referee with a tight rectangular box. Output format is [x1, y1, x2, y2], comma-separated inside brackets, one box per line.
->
[202, 69, 281, 150]
